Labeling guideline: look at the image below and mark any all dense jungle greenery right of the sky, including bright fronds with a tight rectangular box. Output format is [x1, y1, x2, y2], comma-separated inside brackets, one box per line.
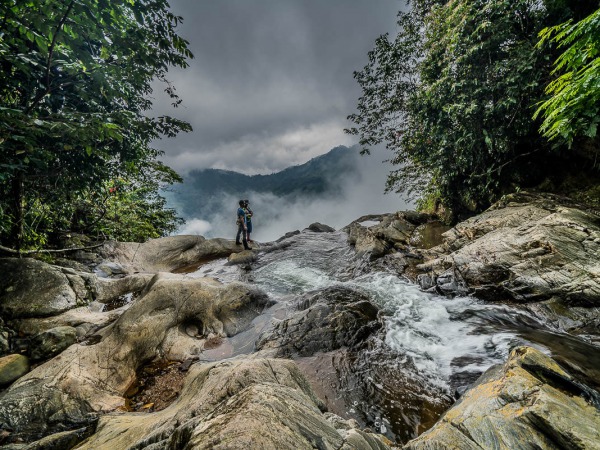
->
[346, 0, 600, 221]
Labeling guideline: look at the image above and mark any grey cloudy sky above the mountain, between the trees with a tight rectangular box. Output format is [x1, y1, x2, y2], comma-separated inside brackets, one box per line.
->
[154, 0, 405, 176]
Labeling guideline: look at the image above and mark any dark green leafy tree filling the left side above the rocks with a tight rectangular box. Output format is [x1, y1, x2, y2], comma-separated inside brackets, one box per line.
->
[0, 0, 192, 247]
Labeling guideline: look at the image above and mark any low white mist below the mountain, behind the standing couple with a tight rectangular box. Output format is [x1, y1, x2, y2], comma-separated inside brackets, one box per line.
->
[177, 150, 412, 242]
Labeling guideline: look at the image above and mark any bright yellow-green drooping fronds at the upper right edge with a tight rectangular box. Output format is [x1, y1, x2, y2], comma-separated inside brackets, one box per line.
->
[536, 9, 600, 145]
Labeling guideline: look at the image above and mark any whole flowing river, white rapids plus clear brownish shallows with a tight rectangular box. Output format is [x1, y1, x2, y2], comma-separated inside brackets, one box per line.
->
[183, 231, 600, 442]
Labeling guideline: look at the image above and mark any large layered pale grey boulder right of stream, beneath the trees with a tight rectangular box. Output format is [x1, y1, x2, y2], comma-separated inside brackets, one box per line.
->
[418, 194, 600, 306]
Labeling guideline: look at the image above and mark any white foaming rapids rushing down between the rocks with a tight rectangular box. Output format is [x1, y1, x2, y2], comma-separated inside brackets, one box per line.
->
[189, 231, 584, 391]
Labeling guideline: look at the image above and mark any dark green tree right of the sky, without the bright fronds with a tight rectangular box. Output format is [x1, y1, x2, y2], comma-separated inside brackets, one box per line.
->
[346, 0, 598, 218]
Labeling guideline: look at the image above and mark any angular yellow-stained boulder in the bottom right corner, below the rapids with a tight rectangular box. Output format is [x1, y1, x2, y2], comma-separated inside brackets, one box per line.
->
[404, 347, 600, 450]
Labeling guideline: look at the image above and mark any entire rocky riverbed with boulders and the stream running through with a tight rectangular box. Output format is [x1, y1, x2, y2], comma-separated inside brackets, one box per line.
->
[0, 193, 600, 449]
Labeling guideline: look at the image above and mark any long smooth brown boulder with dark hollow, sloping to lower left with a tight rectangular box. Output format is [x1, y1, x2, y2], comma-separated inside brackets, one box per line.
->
[0, 274, 268, 439]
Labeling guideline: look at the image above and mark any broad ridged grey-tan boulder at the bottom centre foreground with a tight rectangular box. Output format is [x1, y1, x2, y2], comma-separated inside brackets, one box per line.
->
[77, 359, 389, 450]
